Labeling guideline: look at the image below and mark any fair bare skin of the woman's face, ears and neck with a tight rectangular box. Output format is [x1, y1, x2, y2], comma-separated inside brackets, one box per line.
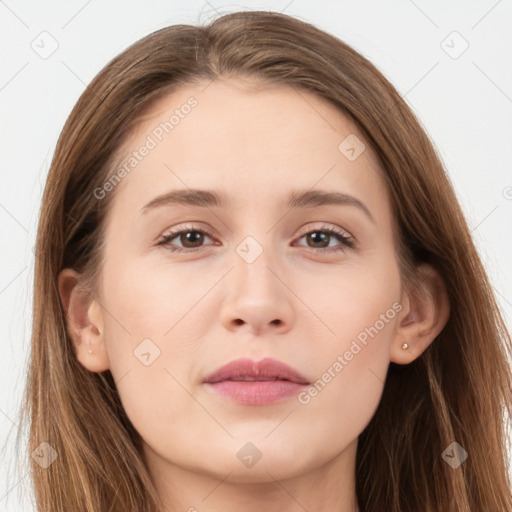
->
[59, 78, 449, 512]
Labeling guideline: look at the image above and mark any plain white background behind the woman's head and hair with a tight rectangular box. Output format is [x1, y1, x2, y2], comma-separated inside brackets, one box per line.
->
[0, 0, 512, 512]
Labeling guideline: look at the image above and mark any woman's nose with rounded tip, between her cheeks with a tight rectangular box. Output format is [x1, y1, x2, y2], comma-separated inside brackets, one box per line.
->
[221, 247, 294, 335]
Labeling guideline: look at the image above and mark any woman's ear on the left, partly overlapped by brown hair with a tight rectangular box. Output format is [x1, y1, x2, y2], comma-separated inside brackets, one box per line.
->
[58, 268, 110, 372]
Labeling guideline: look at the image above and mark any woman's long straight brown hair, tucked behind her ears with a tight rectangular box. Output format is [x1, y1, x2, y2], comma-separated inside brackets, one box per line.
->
[17, 12, 512, 512]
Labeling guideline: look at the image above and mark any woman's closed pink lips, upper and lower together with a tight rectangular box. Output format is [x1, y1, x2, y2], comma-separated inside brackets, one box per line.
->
[203, 358, 309, 405]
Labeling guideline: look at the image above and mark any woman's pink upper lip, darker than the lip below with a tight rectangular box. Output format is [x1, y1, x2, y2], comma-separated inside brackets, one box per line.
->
[204, 357, 309, 384]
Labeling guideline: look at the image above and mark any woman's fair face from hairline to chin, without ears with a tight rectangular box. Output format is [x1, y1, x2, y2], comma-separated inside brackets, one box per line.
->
[95, 79, 402, 482]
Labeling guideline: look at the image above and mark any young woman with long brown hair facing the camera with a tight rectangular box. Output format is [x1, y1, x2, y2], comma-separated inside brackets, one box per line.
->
[19, 12, 512, 512]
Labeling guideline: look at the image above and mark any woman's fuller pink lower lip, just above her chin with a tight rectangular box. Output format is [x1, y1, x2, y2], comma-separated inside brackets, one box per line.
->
[207, 380, 306, 405]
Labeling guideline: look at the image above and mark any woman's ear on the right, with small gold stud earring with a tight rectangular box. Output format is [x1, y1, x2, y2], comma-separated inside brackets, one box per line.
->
[390, 264, 450, 364]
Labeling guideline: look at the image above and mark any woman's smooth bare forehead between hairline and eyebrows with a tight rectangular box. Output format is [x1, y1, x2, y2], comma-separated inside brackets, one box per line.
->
[103, 78, 389, 224]
